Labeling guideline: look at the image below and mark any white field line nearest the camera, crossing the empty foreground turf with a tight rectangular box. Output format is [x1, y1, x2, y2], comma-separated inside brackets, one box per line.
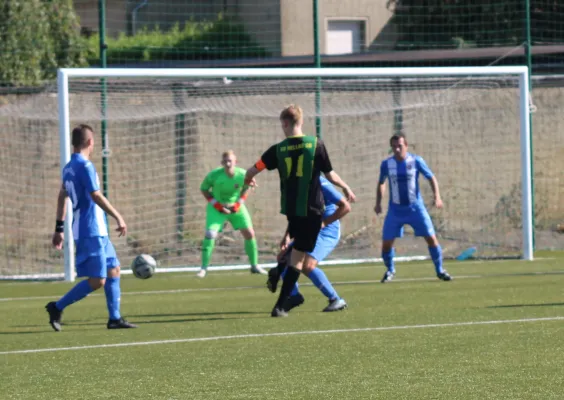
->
[0, 317, 564, 355]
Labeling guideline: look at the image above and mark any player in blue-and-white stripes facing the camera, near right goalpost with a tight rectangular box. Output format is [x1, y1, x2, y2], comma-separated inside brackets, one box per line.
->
[374, 133, 452, 283]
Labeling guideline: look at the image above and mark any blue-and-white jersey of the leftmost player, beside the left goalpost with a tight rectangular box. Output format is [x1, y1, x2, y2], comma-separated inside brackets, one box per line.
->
[63, 153, 108, 240]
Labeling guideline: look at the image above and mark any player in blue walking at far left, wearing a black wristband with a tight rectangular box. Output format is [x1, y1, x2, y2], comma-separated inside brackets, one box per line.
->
[45, 125, 136, 331]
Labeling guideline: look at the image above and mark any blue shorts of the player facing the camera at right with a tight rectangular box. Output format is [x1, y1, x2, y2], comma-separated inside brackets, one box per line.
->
[382, 204, 435, 240]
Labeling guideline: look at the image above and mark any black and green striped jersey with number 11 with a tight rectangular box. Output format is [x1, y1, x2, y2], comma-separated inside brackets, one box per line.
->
[261, 136, 333, 217]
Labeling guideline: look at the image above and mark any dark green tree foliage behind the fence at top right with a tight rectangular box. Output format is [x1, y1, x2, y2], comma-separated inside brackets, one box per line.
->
[388, 0, 564, 49]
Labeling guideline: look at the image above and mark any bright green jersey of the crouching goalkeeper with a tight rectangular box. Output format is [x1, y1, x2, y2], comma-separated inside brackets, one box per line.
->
[200, 167, 247, 204]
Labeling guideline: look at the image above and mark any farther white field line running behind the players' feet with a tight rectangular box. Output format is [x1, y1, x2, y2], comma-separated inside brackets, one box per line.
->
[0, 271, 564, 303]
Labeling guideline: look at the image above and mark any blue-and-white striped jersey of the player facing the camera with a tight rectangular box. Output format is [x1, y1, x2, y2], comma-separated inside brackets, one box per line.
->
[378, 153, 433, 208]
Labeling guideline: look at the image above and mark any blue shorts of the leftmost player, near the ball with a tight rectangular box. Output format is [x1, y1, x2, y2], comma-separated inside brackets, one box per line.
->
[76, 236, 120, 278]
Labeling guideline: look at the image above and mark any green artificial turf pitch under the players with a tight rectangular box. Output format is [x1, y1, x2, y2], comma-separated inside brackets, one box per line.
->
[0, 253, 564, 400]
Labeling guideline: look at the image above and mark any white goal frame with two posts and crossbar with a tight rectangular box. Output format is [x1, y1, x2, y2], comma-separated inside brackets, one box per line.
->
[51, 66, 533, 280]
